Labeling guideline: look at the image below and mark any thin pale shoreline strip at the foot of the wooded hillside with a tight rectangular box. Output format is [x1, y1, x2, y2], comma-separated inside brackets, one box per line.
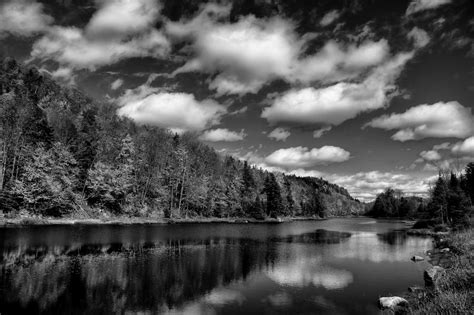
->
[0, 217, 334, 226]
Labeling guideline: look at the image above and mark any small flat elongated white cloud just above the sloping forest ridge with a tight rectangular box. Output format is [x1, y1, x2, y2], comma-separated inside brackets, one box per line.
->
[265, 146, 350, 168]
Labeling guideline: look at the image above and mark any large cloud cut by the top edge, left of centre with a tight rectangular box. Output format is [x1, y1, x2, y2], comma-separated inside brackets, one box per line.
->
[31, 0, 170, 70]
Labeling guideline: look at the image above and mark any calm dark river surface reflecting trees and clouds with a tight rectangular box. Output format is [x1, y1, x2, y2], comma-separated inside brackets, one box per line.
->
[0, 218, 431, 314]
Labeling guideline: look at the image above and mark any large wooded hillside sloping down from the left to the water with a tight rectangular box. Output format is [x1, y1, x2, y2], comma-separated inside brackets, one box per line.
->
[0, 58, 364, 219]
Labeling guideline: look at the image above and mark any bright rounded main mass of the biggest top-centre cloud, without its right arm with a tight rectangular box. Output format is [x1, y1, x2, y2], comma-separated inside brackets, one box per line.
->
[174, 16, 302, 94]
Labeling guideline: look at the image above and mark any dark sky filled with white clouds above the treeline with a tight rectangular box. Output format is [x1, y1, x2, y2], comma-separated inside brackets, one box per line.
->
[0, 0, 474, 201]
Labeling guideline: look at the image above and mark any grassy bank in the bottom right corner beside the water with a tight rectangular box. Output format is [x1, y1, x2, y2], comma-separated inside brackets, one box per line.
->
[407, 228, 474, 314]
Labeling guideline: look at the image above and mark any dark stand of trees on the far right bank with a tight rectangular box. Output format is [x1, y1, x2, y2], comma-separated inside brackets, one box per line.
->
[368, 162, 474, 227]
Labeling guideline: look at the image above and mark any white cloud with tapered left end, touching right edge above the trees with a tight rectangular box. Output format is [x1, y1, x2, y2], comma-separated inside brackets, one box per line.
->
[366, 101, 474, 142]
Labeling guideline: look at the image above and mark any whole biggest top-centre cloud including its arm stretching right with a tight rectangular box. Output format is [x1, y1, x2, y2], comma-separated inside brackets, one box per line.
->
[166, 4, 389, 95]
